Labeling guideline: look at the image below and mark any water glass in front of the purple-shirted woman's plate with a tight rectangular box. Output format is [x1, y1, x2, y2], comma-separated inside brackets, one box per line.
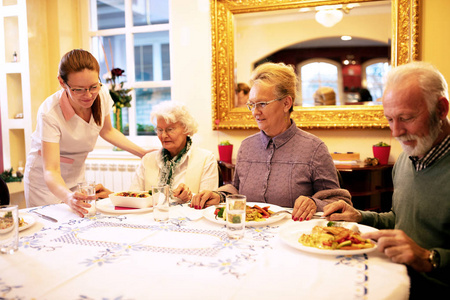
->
[225, 194, 247, 239]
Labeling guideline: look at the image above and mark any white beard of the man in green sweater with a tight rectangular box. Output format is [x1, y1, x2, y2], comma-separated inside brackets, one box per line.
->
[395, 112, 441, 156]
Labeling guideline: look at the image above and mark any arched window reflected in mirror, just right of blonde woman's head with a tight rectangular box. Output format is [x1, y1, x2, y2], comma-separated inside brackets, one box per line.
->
[295, 59, 341, 106]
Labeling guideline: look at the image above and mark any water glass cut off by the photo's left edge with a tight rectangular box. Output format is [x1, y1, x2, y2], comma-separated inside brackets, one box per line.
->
[0, 205, 19, 254]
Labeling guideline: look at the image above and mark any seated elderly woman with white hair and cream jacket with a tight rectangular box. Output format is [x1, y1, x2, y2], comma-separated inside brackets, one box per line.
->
[130, 101, 219, 202]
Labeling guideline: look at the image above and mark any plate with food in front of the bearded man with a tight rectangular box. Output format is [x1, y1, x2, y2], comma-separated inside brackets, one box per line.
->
[279, 220, 378, 255]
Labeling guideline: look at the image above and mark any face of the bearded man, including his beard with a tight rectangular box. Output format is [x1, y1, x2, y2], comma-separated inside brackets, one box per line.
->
[383, 85, 440, 157]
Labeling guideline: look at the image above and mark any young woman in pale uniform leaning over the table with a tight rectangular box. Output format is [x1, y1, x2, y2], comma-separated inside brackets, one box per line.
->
[24, 49, 149, 217]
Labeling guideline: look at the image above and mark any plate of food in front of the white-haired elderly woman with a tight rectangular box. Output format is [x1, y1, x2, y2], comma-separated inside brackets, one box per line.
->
[95, 191, 153, 214]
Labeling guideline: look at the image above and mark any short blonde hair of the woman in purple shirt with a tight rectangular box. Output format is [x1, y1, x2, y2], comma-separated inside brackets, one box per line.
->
[250, 62, 298, 112]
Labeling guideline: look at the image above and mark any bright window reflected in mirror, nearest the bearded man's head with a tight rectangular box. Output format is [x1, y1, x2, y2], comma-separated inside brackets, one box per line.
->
[362, 58, 391, 101]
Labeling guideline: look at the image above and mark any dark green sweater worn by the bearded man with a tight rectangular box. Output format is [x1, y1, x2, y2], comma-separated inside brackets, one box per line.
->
[361, 152, 450, 286]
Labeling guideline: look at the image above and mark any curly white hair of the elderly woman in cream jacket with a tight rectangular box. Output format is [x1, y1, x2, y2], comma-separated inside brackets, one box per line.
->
[150, 101, 198, 136]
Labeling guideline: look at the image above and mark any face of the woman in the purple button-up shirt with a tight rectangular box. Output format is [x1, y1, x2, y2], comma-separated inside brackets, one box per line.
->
[248, 83, 292, 137]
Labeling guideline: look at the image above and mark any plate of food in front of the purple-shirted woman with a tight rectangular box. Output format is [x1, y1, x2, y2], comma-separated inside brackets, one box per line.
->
[203, 202, 290, 227]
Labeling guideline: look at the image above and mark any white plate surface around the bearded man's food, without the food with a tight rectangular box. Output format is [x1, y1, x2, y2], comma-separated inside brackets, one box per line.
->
[279, 220, 378, 255]
